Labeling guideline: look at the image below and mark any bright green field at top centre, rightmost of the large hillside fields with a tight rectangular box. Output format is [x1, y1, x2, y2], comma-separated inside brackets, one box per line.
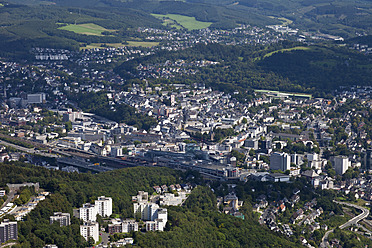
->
[152, 14, 212, 30]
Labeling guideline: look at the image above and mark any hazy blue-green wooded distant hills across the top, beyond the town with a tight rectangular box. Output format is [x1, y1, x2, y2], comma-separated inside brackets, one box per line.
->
[0, 0, 372, 57]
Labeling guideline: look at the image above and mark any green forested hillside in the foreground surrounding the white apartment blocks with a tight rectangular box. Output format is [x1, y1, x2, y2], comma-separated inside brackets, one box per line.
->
[0, 162, 298, 248]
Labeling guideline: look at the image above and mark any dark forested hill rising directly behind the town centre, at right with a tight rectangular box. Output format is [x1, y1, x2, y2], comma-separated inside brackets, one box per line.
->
[116, 42, 372, 96]
